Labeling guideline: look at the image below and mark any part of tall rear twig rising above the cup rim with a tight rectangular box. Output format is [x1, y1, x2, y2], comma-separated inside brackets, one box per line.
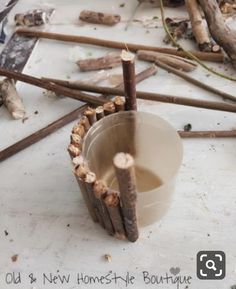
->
[121, 50, 137, 110]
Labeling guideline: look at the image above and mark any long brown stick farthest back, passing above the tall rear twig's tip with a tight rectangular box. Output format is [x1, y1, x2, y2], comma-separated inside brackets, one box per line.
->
[17, 28, 224, 62]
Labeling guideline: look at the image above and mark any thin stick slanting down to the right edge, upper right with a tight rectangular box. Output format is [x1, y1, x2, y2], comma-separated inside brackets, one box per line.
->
[155, 60, 236, 101]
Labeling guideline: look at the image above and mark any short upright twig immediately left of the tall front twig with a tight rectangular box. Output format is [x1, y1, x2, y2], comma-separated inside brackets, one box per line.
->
[104, 191, 126, 240]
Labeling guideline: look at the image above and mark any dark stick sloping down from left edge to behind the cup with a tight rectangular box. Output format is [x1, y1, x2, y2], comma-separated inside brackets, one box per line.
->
[0, 68, 107, 105]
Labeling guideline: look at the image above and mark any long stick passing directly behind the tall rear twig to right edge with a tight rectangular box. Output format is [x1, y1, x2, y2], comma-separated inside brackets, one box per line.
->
[56, 84, 236, 112]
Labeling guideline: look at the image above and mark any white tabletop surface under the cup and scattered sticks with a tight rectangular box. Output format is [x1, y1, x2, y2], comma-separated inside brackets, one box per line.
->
[0, 0, 236, 289]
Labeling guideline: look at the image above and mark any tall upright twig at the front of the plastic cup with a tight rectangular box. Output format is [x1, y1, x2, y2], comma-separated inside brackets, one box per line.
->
[113, 153, 139, 242]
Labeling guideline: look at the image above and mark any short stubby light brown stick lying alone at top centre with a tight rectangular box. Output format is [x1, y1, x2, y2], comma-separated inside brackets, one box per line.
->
[79, 10, 121, 26]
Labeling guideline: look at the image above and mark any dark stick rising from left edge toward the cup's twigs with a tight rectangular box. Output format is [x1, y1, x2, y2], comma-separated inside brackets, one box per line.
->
[0, 106, 84, 162]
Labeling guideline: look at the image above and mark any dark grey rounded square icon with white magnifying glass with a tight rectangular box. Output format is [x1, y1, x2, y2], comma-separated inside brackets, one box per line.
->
[197, 251, 226, 280]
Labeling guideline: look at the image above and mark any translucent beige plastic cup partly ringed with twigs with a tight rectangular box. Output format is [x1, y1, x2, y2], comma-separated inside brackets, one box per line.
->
[83, 111, 183, 226]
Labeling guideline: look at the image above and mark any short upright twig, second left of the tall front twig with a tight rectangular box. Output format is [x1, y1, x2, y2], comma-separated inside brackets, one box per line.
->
[93, 180, 114, 235]
